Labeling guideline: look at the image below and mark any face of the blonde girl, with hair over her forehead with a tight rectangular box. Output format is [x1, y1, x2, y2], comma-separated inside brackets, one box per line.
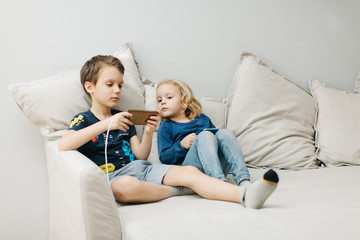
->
[156, 83, 188, 122]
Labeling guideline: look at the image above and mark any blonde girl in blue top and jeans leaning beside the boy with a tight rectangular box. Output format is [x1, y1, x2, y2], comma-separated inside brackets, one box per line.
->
[156, 80, 250, 186]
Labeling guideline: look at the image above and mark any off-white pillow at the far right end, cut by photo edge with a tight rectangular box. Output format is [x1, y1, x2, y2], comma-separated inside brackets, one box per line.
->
[309, 78, 360, 166]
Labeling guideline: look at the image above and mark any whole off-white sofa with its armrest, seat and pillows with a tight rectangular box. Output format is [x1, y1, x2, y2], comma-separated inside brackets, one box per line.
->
[9, 44, 360, 240]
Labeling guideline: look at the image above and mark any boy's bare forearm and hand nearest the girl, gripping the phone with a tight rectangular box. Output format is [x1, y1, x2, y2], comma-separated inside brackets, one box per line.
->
[130, 116, 160, 160]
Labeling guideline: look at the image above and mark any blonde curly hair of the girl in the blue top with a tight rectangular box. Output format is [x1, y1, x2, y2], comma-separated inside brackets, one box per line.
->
[156, 79, 202, 121]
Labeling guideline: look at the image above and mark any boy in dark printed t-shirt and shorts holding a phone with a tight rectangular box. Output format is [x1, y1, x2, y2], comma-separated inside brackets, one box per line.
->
[59, 55, 278, 208]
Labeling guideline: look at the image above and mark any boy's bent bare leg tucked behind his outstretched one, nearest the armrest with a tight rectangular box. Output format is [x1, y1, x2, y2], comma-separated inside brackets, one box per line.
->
[111, 176, 172, 203]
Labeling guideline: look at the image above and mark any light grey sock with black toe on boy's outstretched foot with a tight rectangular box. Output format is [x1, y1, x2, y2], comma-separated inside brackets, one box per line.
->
[240, 169, 279, 209]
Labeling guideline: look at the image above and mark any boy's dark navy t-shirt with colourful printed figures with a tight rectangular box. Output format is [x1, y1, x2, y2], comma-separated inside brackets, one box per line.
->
[69, 109, 136, 172]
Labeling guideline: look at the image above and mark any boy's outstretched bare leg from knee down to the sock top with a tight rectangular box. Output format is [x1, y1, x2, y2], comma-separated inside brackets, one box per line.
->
[163, 166, 241, 202]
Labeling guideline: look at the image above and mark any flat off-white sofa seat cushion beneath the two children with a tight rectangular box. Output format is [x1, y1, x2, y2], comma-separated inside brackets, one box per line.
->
[118, 166, 360, 240]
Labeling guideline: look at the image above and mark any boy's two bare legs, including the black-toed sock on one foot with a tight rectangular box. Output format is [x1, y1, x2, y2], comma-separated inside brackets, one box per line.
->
[111, 166, 279, 209]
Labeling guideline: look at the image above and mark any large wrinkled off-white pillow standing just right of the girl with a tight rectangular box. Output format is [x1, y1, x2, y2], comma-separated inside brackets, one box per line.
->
[227, 52, 316, 169]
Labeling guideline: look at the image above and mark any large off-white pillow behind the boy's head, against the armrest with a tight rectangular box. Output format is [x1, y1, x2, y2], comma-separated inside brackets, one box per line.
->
[9, 43, 145, 139]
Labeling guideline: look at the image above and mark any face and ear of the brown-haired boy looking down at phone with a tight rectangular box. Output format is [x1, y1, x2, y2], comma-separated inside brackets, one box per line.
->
[85, 66, 124, 108]
